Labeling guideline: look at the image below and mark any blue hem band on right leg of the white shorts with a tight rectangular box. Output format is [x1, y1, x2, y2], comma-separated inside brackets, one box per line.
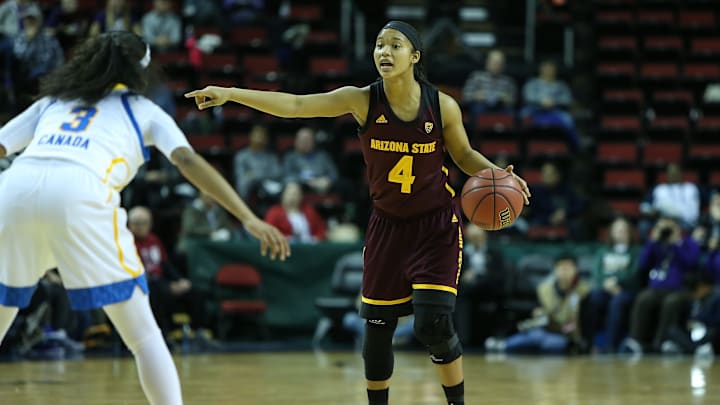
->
[67, 273, 149, 311]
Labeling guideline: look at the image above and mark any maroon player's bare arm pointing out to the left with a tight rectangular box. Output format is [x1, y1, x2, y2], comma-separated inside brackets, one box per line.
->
[185, 86, 370, 122]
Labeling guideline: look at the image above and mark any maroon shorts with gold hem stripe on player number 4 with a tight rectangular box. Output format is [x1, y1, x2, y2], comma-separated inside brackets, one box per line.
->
[360, 206, 463, 319]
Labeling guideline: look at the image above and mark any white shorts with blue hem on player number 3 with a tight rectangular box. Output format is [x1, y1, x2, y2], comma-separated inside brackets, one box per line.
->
[0, 159, 148, 309]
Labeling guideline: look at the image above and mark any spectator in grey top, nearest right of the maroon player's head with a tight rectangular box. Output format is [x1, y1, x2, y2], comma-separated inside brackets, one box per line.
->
[463, 49, 517, 117]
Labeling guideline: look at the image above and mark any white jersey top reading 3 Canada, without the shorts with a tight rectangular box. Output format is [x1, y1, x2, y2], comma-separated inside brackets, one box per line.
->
[0, 86, 190, 190]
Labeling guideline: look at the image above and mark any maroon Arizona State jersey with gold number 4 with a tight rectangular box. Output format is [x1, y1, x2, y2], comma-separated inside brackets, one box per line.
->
[359, 81, 455, 218]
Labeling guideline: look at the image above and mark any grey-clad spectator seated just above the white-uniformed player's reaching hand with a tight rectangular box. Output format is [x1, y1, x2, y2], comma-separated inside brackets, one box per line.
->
[233, 124, 283, 201]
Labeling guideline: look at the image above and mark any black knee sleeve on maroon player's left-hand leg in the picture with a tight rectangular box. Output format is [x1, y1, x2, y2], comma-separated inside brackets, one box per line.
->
[363, 319, 397, 381]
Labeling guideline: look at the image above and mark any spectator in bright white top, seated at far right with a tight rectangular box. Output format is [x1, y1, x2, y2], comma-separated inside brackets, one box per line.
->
[640, 163, 700, 232]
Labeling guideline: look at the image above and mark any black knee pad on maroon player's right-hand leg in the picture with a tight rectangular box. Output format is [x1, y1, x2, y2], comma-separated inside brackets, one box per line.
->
[413, 305, 462, 364]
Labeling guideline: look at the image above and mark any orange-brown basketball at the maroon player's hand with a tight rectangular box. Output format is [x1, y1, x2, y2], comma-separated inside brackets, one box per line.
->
[461, 168, 525, 231]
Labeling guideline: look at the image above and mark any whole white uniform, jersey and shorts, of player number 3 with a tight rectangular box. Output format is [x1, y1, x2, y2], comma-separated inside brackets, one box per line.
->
[0, 89, 189, 309]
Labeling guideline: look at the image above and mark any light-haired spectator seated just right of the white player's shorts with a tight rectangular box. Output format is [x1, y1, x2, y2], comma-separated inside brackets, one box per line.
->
[128, 207, 212, 341]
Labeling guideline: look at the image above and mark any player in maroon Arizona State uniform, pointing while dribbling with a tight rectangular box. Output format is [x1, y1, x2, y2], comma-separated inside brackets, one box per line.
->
[185, 21, 530, 405]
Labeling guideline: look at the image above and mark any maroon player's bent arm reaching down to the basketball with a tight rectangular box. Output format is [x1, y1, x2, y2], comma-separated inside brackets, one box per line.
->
[440, 93, 530, 205]
